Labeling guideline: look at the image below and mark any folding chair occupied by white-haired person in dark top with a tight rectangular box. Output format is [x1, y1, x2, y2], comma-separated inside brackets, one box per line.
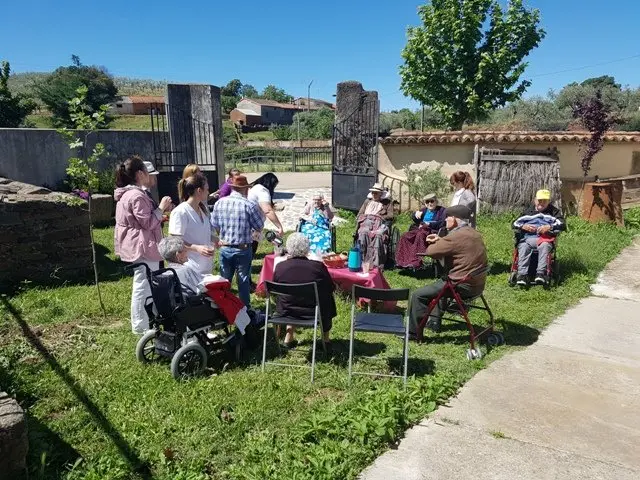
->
[262, 280, 324, 383]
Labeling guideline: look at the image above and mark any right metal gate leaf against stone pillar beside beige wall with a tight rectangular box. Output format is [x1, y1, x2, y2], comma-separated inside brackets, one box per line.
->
[331, 98, 380, 210]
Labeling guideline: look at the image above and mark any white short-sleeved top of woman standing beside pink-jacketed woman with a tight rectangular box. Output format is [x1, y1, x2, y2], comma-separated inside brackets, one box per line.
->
[169, 202, 213, 275]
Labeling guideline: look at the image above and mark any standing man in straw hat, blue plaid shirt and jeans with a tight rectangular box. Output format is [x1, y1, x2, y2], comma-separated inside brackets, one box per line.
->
[211, 175, 264, 308]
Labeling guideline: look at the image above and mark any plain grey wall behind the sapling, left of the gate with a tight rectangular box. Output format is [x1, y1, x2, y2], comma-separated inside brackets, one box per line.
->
[0, 128, 165, 188]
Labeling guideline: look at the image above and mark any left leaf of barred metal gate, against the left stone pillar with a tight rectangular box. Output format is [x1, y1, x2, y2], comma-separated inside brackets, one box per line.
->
[150, 104, 216, 172]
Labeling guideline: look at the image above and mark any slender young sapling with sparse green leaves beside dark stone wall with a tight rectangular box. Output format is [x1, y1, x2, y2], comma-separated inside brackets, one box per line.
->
[58, 85, 109, 317]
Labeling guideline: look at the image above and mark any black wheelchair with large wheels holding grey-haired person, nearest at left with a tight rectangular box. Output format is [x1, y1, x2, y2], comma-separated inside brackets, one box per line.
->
[126, 263, 243, 380]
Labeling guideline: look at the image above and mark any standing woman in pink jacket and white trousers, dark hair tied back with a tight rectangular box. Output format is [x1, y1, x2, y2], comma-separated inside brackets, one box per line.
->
[113, 156, 172, 335]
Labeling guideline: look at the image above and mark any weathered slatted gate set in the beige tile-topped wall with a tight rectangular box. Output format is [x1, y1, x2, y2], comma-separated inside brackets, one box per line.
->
[474, 145, 562, 213]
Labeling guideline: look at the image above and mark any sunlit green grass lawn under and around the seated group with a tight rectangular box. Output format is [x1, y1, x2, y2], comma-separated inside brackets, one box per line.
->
[0, 217, 634, 480]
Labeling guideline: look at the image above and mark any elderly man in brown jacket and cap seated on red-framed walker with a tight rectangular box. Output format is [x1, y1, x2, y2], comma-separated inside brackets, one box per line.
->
[409, 205, 487, 334]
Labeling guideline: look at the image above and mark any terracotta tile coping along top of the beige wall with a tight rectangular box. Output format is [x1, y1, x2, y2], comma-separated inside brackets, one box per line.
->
[380, 131, 640, 145]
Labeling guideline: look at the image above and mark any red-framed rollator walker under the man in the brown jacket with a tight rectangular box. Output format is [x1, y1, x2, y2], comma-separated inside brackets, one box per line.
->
[416, 266, 504, 360]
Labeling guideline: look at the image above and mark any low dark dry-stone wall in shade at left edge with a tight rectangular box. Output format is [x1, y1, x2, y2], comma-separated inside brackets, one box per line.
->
[0, 177, 91, 286]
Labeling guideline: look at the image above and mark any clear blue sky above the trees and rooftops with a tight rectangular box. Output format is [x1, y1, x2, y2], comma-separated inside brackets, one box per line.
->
[5, 0, 640, 110]
